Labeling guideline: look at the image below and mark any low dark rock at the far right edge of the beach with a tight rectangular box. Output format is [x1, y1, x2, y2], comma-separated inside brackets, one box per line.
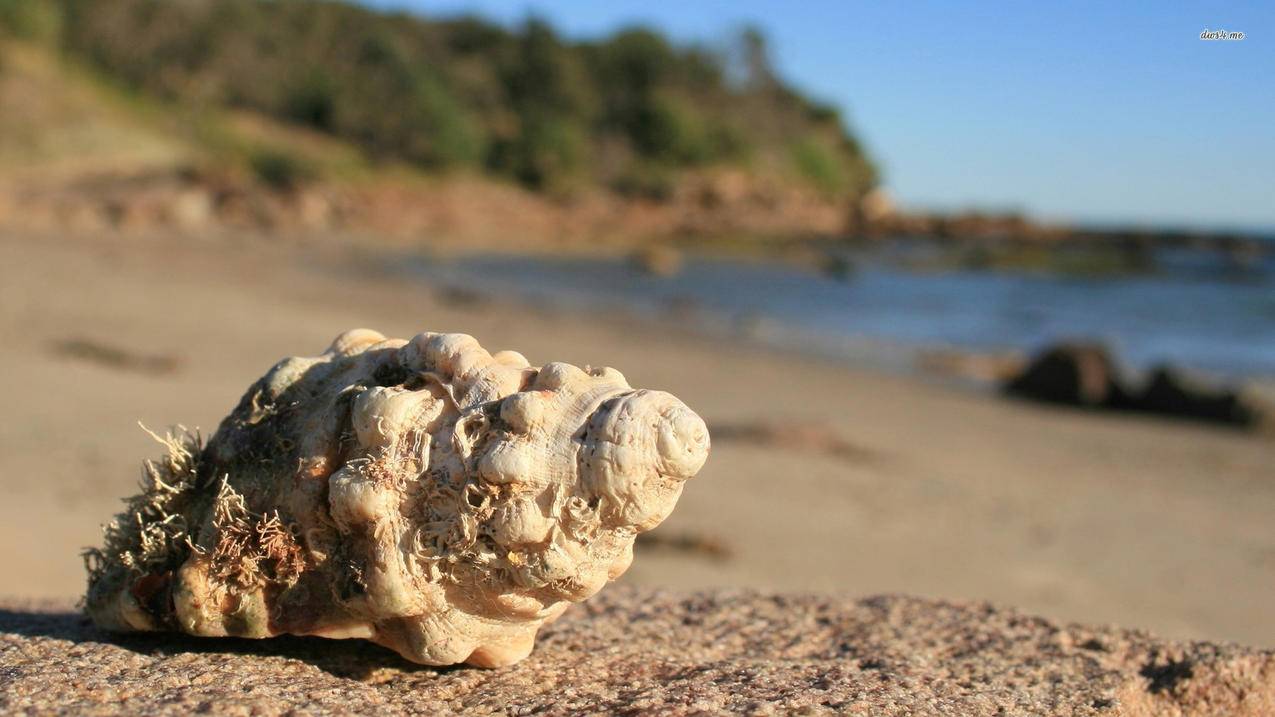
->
[1132, 366, 1262, 427]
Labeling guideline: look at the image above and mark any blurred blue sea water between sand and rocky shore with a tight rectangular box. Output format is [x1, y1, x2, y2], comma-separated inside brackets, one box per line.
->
[397, 245, 1275, 378]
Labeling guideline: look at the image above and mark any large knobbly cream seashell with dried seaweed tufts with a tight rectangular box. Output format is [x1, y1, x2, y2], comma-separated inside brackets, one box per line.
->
[85, 329, 709, 666]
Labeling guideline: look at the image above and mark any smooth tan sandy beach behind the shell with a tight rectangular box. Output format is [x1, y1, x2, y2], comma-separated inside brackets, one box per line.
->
[0, 233, 1275, 647]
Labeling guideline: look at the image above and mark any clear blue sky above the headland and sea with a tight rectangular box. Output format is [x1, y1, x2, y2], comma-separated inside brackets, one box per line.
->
[365, 0, 1275, 231]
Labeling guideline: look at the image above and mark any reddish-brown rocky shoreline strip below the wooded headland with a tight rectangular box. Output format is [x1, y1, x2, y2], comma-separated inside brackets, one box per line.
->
[0, 158, 1275, 262]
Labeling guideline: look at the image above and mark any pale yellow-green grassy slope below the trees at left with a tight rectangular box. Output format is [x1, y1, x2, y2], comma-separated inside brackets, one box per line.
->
[0, 40, 392, 180]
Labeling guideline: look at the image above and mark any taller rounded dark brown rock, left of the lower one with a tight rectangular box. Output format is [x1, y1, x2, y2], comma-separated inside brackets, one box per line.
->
[1005, 343, 1128, 408]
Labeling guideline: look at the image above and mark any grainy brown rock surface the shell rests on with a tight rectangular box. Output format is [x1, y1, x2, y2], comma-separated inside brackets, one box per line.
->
[0, 586, 1275, 716]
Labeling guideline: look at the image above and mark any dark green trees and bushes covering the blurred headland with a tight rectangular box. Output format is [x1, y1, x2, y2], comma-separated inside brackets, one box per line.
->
[0, 0, 876, 199]
